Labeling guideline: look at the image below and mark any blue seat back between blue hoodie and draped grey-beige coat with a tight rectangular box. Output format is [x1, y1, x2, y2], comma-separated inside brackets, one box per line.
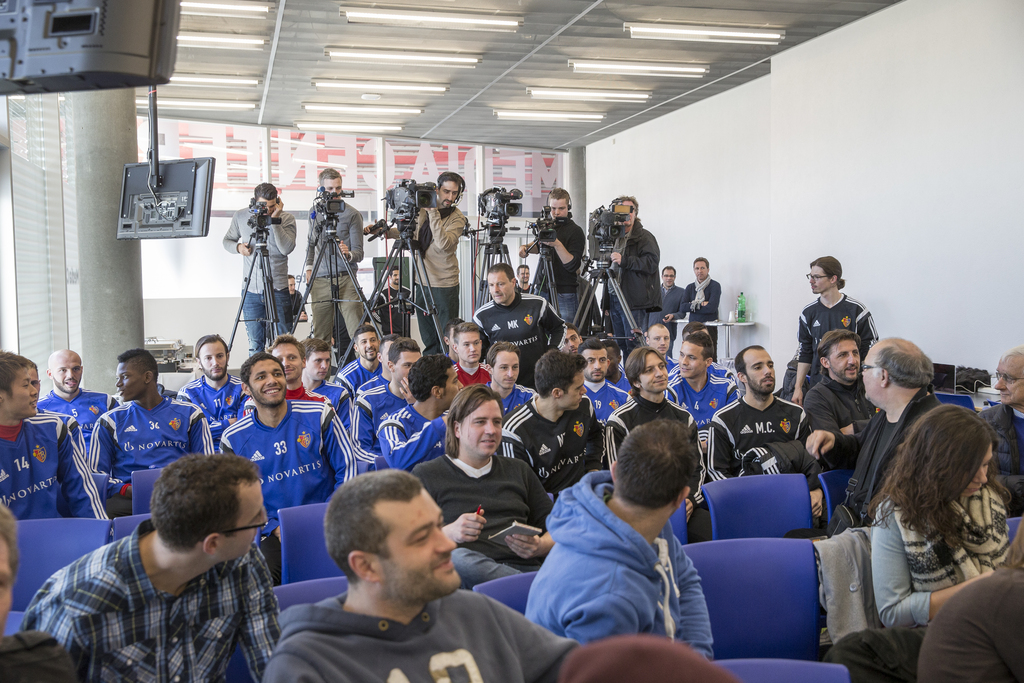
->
[686, 540, 819, 663]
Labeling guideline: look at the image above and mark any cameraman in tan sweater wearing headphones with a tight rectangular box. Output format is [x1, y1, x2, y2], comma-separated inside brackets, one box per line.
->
[376, 171, 469, 355]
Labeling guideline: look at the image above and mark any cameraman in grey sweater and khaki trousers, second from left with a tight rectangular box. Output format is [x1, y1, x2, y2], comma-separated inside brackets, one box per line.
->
[305, 168, 362, 350]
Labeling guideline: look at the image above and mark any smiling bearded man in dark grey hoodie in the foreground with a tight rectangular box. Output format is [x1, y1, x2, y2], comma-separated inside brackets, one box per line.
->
[263, 470, 577, 683]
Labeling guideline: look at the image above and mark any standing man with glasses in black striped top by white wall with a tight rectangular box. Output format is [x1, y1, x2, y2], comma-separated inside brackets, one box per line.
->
[793, 256, 879, 405]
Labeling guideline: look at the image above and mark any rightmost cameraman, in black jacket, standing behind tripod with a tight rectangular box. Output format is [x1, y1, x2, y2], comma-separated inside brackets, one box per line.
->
[609, 196, 662, 357]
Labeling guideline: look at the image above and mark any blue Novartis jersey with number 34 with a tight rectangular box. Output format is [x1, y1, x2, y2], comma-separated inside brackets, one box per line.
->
[92, 398, 213, 496]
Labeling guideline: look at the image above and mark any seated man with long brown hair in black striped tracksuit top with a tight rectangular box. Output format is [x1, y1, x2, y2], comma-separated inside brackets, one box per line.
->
[604, 346, 712, 543]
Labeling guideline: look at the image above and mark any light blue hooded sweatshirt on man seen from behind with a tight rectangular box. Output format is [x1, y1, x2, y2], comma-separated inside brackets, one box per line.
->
[526, 472, 714, 658]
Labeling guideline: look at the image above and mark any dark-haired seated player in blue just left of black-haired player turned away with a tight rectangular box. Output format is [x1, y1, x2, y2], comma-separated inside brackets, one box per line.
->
[352, 337, 422, 456]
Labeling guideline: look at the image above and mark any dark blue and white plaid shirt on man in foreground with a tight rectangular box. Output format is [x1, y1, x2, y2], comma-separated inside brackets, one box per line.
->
[23, 520, 281, 683]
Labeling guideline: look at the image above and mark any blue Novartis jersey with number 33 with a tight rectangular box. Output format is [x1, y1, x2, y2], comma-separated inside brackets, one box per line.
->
[220, 400, 355, 535]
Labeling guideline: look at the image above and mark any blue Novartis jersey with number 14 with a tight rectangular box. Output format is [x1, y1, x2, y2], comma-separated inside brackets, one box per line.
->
[0, 412, 106, 519]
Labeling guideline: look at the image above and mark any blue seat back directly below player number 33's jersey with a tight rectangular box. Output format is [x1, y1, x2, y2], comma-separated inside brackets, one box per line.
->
[278, 503, 344, 584]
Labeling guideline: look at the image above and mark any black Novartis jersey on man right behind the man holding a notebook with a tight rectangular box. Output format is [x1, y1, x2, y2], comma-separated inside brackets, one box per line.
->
[502, 396, 604, 494]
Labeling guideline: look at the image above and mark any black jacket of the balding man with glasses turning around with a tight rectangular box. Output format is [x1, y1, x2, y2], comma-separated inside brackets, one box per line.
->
[821, 385, 942, 522]
